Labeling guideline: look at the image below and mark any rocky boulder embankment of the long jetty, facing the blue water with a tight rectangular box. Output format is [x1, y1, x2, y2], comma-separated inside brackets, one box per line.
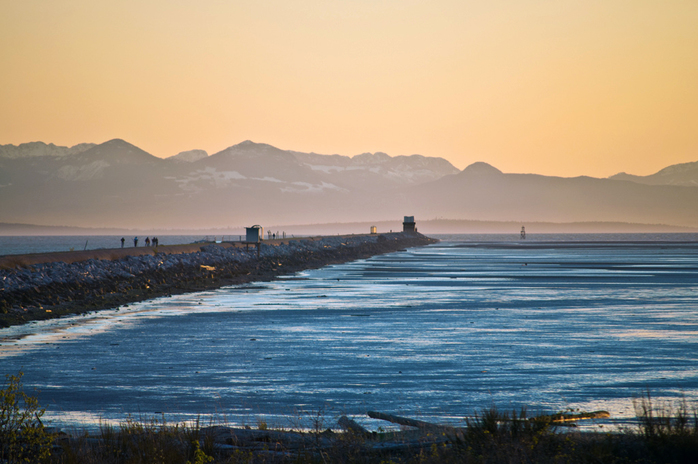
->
[0, 233, 436, 327]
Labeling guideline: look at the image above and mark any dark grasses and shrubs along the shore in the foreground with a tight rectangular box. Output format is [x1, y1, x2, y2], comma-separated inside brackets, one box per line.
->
[0, 373, 698, 464]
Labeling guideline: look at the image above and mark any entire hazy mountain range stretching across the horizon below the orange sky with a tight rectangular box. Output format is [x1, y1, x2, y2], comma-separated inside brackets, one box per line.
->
[0, 139, 698, 232]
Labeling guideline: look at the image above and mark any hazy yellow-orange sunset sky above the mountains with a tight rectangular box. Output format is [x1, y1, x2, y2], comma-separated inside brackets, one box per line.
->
[0, 0, 698, 177]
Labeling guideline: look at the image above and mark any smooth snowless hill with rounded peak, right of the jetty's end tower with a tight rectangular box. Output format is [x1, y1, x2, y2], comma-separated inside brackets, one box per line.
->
[388, 163, 698, 227]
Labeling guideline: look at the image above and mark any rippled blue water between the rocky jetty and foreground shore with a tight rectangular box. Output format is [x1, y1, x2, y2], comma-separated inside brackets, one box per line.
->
[0, 234, 698, 428]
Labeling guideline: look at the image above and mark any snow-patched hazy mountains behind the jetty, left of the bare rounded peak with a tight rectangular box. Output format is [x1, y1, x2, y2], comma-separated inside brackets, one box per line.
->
[0, 139, 458, 229]
